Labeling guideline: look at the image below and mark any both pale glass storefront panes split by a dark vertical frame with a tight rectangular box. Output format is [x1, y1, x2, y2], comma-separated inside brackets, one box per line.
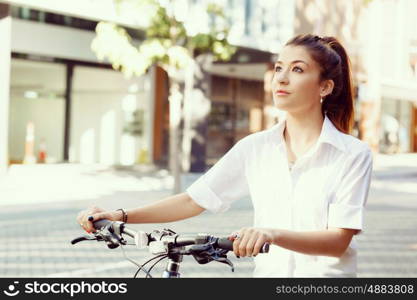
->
[9, 58, 153, 165]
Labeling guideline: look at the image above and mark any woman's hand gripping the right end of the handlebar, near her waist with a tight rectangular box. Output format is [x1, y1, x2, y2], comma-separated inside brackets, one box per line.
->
[229, 227, 274, 257]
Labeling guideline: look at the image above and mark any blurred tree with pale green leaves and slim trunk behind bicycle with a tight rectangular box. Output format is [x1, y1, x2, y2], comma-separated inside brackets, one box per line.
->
[92, 0, 236, 193]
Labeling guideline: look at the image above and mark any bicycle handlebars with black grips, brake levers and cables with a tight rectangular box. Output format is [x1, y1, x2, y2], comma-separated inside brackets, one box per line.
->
[71, 220, 269, 278]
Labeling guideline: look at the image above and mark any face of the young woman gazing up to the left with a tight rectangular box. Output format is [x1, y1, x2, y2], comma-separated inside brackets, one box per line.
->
[272, 46, 322, 112]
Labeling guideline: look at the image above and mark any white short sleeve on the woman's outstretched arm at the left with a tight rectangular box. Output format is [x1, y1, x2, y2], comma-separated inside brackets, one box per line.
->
[186, 138, 249, 213]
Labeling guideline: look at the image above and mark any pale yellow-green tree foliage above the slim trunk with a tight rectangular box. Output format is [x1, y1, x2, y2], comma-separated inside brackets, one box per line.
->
[92, 0, 236, 77]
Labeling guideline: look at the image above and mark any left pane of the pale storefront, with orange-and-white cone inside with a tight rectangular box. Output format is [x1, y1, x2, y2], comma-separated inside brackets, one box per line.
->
[9, 59, 66, 163]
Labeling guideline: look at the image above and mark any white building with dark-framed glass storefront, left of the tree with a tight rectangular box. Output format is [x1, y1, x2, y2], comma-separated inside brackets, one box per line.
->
[0, 1, 155, 175]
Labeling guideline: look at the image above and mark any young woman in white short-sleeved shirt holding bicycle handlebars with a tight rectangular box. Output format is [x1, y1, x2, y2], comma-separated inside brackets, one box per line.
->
[78, 35, 372, 277]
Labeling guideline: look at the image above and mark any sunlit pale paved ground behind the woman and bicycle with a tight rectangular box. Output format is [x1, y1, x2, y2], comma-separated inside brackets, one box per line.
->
[0, 154, 417, 277]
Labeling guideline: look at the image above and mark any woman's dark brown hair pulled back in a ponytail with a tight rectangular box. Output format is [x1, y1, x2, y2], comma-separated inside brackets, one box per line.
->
[285, 34, 354, 134]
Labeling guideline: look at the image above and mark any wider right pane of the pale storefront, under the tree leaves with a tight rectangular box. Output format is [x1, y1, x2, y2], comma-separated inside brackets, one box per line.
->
[70, 66, 153, 165]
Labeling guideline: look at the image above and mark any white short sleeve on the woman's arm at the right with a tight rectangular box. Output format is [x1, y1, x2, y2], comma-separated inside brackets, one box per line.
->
[328, 148, 372, 230]
